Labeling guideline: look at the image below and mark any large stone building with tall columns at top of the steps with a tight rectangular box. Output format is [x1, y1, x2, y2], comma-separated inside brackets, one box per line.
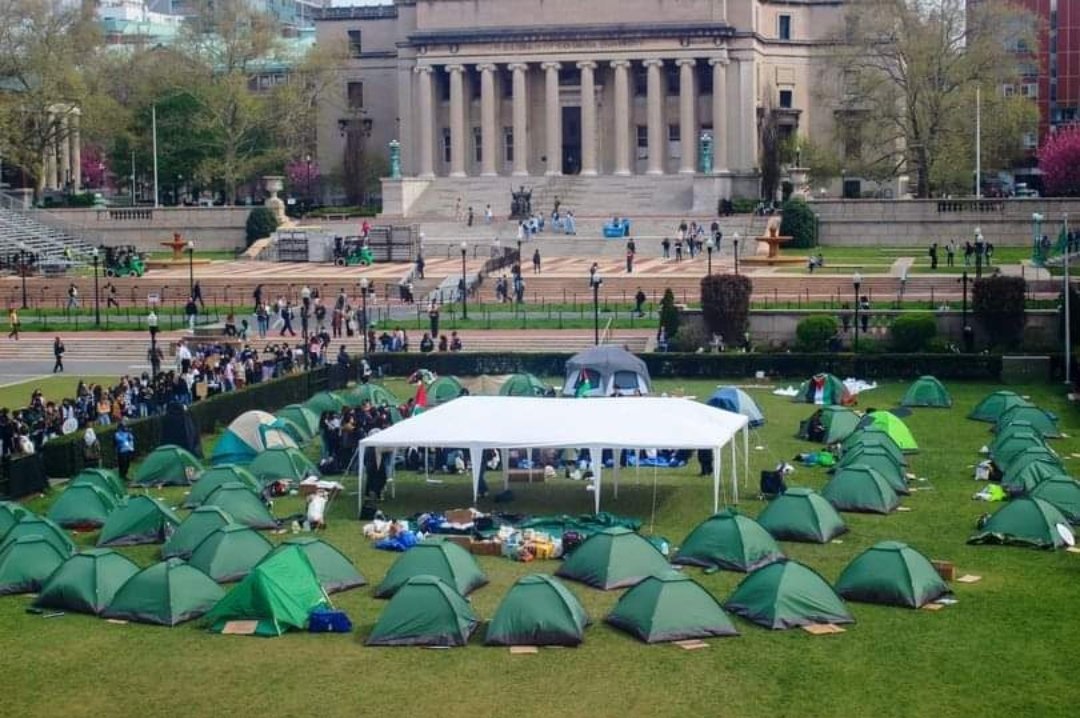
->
[315, 0, 842, 214]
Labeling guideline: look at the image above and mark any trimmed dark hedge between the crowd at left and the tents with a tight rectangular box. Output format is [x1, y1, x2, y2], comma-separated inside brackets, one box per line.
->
[41, 367, 348, 477]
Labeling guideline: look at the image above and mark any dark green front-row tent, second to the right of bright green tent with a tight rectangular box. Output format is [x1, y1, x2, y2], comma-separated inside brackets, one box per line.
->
[484, 573, 589, 646]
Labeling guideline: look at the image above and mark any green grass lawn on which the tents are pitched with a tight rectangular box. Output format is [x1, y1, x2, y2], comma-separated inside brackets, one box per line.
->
[0, 380, 1080, 716]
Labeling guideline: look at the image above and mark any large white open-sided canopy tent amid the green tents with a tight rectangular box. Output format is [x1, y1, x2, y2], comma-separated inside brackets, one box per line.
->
[357, 396, 750, 512]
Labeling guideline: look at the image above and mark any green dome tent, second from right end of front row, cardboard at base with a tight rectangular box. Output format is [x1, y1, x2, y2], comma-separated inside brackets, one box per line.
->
[724, 560, 854, 629]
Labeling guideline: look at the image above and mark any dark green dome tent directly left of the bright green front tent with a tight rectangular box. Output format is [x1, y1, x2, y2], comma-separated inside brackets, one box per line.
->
[102, 558, 225, 626]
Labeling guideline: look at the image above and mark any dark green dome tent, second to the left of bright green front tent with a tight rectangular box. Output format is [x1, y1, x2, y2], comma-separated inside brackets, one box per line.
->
[33, 548, 138, 615]
